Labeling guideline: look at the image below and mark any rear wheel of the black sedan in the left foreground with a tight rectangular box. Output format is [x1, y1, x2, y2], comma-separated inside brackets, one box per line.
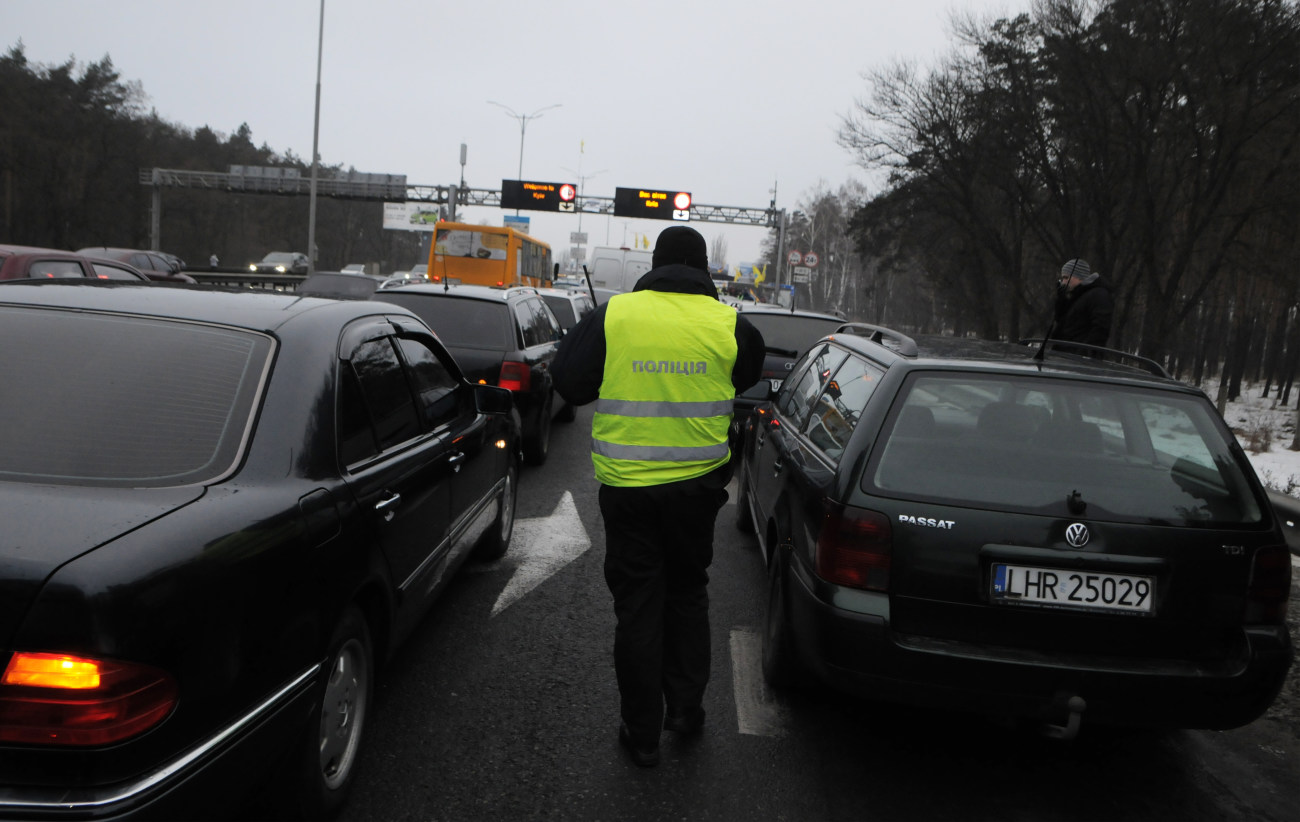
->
[299, 606, 374, 819]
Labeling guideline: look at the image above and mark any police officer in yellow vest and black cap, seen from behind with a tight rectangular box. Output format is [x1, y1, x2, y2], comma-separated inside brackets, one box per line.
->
[551, 226, 763, 767]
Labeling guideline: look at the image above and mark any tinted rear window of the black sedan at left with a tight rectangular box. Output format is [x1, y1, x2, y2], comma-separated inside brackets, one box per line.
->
[0, 306, 273, 488]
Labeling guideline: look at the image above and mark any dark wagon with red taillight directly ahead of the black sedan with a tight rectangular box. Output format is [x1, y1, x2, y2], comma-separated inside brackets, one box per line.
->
[371, 284, 576, 464]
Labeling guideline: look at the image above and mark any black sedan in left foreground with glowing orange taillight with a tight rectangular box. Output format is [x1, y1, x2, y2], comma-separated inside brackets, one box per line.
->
[0, 281, 520, 818]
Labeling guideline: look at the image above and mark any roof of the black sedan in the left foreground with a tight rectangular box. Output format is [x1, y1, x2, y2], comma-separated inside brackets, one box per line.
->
[0, 280, 413, 333]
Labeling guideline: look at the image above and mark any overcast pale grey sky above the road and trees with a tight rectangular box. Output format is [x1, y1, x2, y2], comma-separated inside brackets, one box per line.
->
[0, 0, 1030, 264]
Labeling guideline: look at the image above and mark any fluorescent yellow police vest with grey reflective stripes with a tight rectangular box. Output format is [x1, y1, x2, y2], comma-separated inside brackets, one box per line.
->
[592, 291, 736, 486]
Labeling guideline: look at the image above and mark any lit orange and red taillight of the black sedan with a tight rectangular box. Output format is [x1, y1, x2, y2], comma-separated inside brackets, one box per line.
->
[0, 652, 177, 747]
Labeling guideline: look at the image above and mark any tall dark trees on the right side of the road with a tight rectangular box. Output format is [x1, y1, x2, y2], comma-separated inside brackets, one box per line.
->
[768, 0, 1300, 399]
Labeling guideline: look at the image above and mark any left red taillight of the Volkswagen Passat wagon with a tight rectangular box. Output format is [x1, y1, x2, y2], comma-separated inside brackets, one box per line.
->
[816, 502, 893, 590]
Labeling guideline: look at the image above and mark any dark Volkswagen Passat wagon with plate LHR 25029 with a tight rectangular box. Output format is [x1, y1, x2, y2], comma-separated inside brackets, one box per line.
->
[738, 326, 1292, 737]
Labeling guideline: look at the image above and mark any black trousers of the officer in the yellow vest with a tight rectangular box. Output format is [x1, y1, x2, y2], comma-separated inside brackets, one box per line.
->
[601, 466, 731, 745]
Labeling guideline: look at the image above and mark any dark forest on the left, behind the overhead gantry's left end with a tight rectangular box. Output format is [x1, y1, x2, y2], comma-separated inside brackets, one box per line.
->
[0, 42, 420, 271]
